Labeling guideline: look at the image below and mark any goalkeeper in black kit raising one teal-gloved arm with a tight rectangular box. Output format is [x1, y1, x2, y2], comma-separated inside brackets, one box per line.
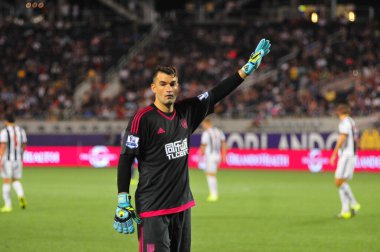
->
[114, 39, 270, 252]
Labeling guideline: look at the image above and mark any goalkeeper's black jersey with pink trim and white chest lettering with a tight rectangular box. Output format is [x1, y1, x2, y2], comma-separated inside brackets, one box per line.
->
[121, 92, 214, 218]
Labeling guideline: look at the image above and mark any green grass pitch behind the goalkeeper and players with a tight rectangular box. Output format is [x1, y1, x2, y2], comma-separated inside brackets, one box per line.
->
[0, 168, 380, 252]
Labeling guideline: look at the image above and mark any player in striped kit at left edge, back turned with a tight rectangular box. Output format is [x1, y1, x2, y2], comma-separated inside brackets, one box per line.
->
[0, 114, 27, 213]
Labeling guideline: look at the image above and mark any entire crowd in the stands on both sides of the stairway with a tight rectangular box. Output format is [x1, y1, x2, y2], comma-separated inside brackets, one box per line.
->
[0, 1, 380, 120]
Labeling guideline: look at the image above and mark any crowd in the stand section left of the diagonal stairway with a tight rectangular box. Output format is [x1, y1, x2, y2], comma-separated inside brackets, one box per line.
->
[0, 2, 150, 120]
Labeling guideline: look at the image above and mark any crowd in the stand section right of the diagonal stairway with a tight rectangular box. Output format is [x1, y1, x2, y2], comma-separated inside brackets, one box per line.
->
[114, 20, 380, 119]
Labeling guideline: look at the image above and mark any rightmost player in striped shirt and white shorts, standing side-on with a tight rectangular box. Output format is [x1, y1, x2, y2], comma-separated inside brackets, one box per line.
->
[330, 104, 360, 219]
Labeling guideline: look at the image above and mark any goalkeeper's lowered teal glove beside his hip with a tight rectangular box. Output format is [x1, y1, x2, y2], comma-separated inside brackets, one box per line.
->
[113, 193, 142, 234]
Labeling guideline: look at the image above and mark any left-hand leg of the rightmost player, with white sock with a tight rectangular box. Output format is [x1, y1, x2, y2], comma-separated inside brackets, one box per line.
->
[335, 156, 351, 219]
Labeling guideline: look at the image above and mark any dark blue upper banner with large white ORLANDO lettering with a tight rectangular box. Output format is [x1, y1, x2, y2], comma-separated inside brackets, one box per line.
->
[28, 131, 380, 150]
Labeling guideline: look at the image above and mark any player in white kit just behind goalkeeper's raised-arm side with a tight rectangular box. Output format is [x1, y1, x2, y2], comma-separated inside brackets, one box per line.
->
[199, 118, 227, 202]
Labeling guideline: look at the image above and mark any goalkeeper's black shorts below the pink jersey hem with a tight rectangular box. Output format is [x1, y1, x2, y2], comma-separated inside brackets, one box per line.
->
[138, 209, 191, 252]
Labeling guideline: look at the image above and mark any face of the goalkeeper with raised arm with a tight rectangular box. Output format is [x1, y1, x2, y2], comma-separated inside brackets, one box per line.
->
[151, 72, 179, 107]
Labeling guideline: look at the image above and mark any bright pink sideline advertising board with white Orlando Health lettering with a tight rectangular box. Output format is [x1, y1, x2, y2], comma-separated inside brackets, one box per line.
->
[24, 146, 380, 172]
